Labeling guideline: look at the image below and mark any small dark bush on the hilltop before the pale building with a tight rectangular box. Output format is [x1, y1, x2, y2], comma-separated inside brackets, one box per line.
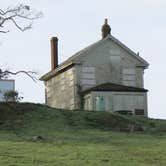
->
[4, 90, 23, 102]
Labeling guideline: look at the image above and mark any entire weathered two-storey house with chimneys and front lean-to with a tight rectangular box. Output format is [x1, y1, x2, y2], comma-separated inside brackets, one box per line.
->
[41, 19, 149, 116]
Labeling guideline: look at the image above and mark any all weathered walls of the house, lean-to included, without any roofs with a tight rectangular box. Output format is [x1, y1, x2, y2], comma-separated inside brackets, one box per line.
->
[45, 39, 147, 115]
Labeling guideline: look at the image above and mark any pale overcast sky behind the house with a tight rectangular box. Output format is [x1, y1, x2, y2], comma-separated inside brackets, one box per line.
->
[0, 0, 166, 119]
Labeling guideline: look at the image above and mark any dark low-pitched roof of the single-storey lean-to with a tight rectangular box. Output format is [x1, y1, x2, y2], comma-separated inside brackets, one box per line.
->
[82, 83, 148, 94]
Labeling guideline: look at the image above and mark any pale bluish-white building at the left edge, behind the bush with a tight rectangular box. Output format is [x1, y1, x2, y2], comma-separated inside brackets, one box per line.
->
[0, 79, 15, 102]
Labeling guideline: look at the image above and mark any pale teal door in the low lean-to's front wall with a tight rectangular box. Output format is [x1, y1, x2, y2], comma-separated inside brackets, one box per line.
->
[95, 96, 105, 111]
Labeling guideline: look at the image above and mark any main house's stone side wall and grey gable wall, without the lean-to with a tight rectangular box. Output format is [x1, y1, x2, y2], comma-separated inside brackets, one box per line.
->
[45, 39, 148, 109]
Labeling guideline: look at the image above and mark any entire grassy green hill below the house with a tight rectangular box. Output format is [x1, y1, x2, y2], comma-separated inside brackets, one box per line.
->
[0, 103, 166, 166]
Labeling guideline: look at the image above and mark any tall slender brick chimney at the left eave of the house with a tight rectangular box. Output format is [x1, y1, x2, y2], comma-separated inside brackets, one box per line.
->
[51, 37, 58, 70]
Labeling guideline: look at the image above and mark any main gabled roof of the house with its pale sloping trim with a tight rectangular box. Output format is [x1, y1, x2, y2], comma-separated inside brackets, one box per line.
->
[40, 35, 149, 81]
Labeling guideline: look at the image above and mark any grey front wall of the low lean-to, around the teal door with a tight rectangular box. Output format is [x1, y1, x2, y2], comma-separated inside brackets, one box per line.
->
[91, 92, 148, 116]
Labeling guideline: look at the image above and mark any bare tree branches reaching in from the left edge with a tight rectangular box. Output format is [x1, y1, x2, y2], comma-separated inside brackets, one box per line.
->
[0, 4, 43, 82]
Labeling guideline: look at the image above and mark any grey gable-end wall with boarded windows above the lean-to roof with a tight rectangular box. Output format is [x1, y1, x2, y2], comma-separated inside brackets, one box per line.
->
[77, 39, 144, 90]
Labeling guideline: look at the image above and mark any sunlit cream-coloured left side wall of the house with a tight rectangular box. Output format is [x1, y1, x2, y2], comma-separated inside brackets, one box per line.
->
[45, 67, 75, 109]
